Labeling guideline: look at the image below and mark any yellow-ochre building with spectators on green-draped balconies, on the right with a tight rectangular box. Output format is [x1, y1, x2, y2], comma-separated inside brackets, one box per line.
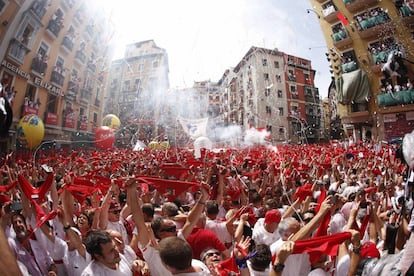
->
[308, 0, 414, 140]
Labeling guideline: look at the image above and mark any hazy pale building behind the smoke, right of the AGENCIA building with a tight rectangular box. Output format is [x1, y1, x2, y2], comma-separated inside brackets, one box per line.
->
[105, 40, 172, 142]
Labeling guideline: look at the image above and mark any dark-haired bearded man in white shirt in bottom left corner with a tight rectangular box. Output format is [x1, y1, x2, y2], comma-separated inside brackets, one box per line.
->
[8, 213, 55, 276]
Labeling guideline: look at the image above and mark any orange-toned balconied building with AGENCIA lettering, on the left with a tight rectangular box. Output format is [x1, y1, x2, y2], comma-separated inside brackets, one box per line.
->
[0, 0, 113, 152]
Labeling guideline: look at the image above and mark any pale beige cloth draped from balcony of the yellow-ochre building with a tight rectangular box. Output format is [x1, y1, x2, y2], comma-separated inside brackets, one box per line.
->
[336, 69, 371, 104]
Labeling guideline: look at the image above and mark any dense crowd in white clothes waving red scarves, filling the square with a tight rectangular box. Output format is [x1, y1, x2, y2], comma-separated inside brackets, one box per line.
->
[0, 137, 414, 276]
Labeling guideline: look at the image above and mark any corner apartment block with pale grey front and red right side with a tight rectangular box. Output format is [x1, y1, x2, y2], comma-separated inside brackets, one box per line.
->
[219, 47, 323, 143]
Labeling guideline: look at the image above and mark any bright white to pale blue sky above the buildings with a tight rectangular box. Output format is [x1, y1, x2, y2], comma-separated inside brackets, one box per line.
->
[100, 0, 331, 97]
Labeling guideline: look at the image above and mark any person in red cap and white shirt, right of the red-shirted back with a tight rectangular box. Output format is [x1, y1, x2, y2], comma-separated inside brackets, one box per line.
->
[252, 209, 282, 246]
